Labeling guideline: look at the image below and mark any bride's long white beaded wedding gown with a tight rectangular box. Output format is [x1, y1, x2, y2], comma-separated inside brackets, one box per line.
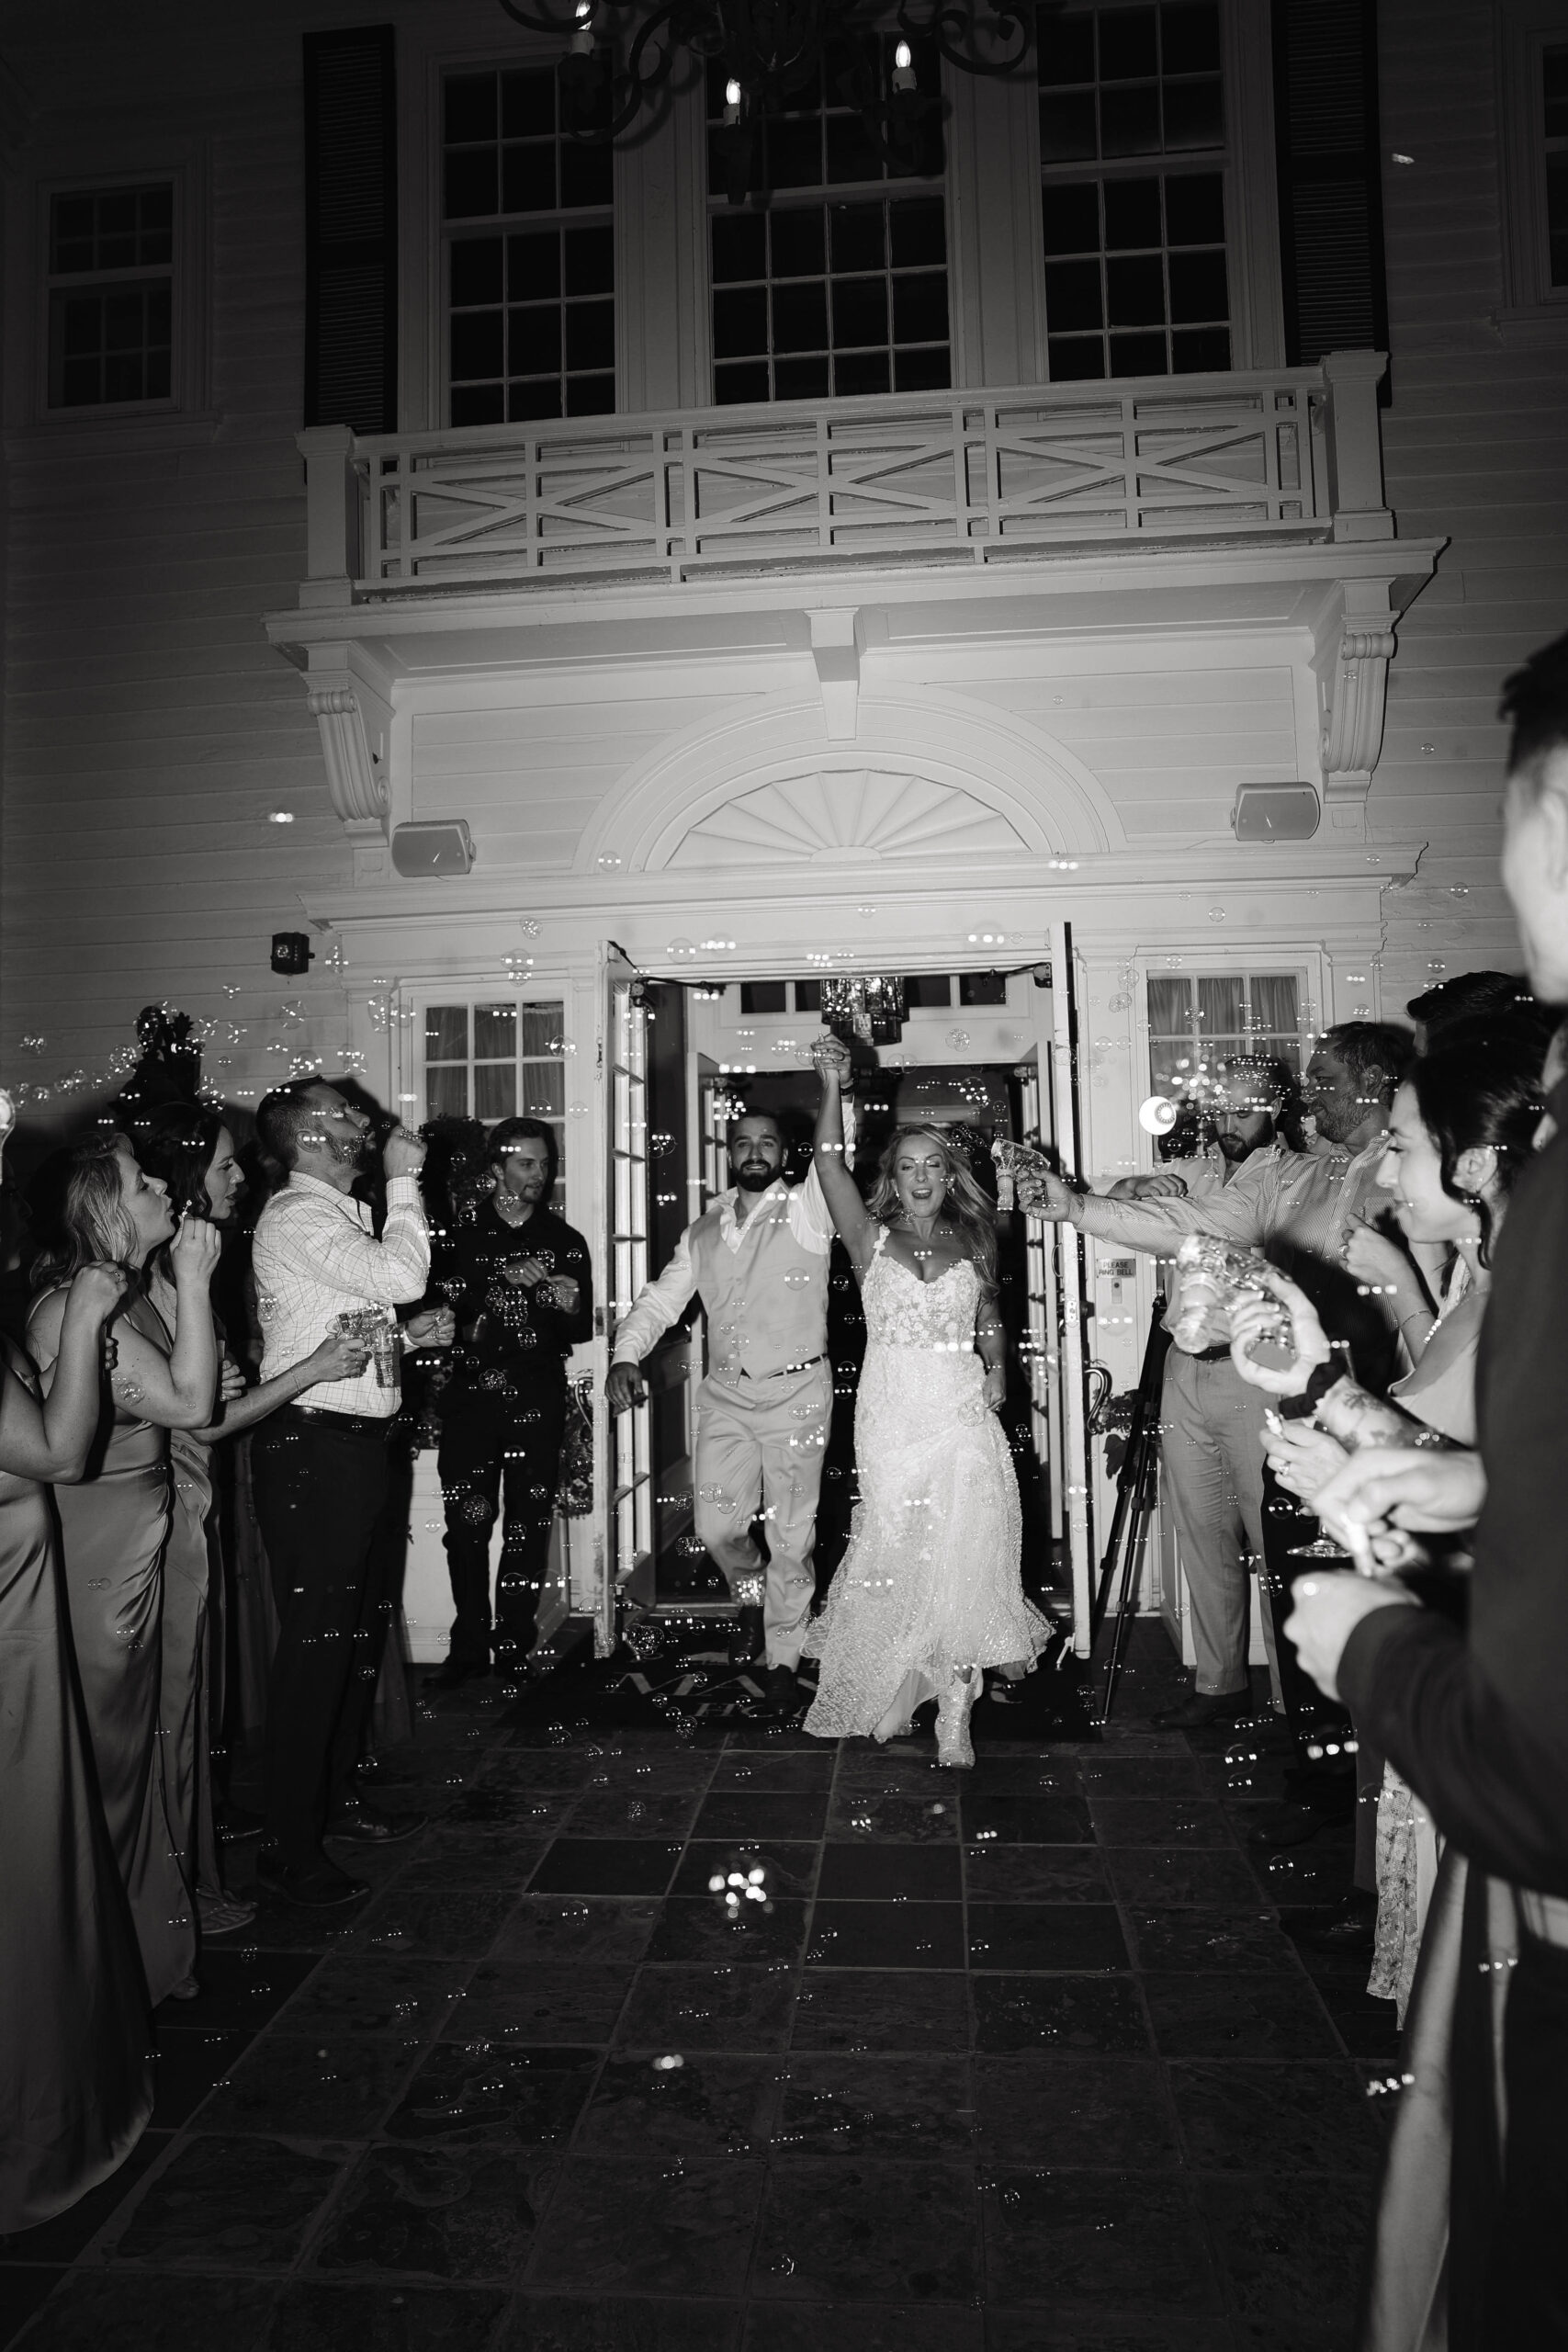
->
[804, 1227, 1051, 1740]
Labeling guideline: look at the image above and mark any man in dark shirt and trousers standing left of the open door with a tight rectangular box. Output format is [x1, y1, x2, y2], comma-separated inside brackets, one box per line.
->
[425, 1120, 592, 1691]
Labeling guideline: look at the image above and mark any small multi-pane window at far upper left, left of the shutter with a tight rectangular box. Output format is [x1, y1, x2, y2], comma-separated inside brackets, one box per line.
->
[50, 181, 174, 409]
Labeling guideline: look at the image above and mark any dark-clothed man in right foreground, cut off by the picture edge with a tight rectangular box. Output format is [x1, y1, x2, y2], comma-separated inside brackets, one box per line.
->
[1288, 638, 1568, 2352]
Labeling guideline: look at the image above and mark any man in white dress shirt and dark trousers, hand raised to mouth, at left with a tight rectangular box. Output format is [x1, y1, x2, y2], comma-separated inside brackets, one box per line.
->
[252, 1080, 451, 1910]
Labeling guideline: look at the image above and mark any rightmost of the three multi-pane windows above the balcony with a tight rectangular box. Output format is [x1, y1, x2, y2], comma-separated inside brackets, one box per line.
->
[1039, 0, 1229, 383]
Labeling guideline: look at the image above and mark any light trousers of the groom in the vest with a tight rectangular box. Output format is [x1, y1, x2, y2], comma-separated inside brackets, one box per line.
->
[691, 1357, 832, 1668]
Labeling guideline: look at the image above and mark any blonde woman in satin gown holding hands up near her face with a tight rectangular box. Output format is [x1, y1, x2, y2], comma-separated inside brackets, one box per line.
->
[28, 1136, 219, 2007]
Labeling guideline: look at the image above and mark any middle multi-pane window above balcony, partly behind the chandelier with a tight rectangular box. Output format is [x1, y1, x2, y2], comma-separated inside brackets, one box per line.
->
[707, 38, 952, 402]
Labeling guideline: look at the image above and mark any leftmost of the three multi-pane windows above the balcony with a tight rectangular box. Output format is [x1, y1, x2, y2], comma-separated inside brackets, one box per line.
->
[442, 66, 616, 425]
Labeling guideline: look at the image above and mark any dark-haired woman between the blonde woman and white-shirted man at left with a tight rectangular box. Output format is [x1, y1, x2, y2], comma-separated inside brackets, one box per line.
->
[136, 1105, 380, 1938]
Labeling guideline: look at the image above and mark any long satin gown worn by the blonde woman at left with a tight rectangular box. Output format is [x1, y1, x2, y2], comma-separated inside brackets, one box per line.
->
[40, 1298, 195, 2007]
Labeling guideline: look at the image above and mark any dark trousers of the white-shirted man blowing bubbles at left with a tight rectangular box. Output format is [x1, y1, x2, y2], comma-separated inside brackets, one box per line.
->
[252, 1407, 390, 1870]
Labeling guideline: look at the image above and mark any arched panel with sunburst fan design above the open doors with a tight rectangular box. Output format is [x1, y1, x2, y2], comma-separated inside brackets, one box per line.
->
[576, 687, 1123, 873]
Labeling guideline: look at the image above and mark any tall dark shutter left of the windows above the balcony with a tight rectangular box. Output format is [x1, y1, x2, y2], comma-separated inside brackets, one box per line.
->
[306, 24, 398, 433]
